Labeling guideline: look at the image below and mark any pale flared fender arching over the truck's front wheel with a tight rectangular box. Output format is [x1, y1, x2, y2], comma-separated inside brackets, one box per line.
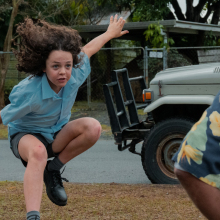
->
[144, 95, 215, 113]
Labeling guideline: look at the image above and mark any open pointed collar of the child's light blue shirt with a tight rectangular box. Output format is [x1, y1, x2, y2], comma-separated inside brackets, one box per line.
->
[42, 73, 76, 99]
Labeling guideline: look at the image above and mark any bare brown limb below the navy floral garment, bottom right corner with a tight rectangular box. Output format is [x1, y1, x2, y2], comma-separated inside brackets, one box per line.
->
[174, 168, 220, 220]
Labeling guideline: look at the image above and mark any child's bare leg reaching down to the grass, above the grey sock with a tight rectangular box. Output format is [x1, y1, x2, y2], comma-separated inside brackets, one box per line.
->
[18, 135, 47, 212]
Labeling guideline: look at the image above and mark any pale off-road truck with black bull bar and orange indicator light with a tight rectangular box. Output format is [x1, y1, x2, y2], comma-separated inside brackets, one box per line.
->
[103, 63, 220, 184]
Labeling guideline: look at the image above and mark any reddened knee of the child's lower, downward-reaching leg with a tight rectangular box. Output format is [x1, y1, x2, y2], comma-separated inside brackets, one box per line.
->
[29, 144, 47, 164]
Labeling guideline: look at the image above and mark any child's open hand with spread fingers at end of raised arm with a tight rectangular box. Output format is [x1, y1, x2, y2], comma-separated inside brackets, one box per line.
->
[106, 15, 129, 39]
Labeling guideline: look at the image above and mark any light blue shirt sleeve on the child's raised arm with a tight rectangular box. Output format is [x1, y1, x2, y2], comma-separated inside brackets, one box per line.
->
[72, 52, 91, 86]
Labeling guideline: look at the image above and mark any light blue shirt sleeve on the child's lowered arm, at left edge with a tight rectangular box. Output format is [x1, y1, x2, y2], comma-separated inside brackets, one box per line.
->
[1, 86, 33, 125]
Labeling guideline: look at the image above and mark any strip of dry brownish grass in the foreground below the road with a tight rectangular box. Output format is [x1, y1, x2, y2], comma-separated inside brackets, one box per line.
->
[0, 182, 205, 220]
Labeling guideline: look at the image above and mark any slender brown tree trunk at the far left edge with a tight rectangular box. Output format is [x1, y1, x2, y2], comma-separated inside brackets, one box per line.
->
[0, 0, 21, 109]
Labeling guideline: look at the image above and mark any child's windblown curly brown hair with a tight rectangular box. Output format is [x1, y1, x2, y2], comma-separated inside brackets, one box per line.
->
[13, 18, 82, 76]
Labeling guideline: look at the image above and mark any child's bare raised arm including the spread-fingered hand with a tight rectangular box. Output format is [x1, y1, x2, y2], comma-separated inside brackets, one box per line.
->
[82, 15, 129, 58]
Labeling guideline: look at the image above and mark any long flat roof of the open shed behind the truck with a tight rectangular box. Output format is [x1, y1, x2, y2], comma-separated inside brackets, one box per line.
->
[73, 20, 220, 40]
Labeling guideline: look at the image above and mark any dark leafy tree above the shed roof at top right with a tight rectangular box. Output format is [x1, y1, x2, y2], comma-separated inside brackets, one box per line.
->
[110, 0, 220, 24]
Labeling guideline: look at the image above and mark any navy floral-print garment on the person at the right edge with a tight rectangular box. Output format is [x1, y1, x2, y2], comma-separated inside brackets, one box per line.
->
[173, 92, 220, 188]
